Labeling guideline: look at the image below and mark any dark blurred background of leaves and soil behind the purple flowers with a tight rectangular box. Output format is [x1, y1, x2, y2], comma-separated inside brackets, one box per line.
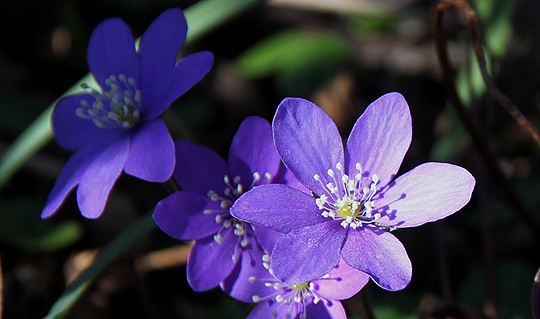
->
[0, 0, 540, 319]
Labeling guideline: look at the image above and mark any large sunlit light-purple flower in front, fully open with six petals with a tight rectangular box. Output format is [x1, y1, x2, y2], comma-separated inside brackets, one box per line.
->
[231, 93, 475, 290]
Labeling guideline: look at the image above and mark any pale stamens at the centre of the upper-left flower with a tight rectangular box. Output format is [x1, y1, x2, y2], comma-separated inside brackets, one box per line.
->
[75, 74, 141, 129]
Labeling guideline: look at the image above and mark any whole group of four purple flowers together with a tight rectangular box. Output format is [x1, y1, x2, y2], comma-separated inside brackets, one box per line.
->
[42, 9, 475, 319]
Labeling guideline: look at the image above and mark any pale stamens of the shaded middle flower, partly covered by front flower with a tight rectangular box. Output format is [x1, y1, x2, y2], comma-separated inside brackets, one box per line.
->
[203, 172, 272, 262]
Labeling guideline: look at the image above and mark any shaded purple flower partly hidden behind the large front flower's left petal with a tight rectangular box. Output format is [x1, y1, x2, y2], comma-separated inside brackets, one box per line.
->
[154, 117, 284, 291]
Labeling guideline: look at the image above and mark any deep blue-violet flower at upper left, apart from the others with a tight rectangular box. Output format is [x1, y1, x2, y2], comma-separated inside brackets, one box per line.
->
[41, 8, 213, 218]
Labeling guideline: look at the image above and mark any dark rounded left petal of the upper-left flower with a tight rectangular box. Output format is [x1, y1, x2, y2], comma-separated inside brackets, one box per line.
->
[51, 93, 119, 150]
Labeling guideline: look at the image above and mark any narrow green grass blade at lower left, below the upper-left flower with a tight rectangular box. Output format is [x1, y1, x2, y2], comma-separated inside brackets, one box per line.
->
[44, 214, 157, 319]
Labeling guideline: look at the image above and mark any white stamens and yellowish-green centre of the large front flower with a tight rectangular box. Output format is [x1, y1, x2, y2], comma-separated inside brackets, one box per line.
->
[313, 163, 380, 229]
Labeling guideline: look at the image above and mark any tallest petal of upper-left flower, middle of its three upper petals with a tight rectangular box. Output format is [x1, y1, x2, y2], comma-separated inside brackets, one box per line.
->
[139, 8, 187, 119]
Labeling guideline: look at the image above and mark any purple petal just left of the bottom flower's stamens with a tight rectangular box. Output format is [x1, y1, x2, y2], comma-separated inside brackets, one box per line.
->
[220, 244, 275, 303]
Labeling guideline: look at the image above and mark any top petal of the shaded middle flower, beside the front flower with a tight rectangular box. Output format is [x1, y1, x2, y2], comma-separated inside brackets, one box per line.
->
[229, 116, 280, 189]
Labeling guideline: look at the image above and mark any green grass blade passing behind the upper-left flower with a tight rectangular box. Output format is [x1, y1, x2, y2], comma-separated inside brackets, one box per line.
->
[0, 0, 263, 189]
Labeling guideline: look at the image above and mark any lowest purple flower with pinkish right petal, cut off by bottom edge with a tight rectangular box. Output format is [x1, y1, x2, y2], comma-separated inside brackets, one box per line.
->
[221, 228, 369, 319]
